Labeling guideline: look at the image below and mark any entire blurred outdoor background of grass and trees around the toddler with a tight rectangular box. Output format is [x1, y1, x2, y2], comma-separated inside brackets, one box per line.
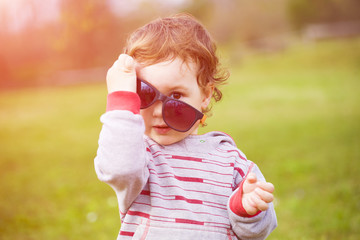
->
[0, 0, 360, 240]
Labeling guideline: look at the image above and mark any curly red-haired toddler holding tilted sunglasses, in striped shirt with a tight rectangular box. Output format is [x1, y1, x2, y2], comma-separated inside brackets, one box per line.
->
[95, 14, 277, 240]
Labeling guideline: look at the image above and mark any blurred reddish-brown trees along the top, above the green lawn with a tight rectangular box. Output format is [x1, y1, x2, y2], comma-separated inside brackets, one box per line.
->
[0, 0, 360, 87]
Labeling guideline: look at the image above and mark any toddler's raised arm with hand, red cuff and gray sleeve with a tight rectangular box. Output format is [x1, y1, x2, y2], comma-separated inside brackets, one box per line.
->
[95, 54, 149, 212]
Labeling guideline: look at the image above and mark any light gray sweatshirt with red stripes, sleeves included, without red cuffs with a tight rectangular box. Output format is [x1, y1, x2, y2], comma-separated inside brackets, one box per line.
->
[95, 91, 276, 240]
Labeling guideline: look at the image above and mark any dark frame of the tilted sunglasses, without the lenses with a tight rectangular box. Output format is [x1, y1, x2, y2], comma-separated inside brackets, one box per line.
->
[136, 78, 206, 132]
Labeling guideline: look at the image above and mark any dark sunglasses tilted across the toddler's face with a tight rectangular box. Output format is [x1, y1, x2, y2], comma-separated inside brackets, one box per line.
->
[137, 79, 206, 132]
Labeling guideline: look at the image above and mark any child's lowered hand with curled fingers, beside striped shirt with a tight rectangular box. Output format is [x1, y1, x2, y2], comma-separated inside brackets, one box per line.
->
[242, 172, 274, 215]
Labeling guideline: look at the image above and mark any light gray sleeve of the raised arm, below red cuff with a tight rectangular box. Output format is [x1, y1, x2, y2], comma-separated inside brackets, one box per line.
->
[94, 110, 149, 212]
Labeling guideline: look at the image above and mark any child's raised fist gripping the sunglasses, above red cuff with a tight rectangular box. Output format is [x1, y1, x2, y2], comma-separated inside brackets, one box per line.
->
[106, 54, 136, 93]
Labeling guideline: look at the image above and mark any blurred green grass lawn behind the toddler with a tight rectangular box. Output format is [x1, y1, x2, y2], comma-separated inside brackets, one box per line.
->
[0, 39, 360, 240]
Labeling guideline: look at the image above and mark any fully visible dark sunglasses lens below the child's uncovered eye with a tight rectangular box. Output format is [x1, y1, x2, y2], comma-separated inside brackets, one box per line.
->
[163, 100, 196, 132]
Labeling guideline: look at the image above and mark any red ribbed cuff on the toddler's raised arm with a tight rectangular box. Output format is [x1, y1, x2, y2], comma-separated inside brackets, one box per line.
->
[106, 91, 141, 114]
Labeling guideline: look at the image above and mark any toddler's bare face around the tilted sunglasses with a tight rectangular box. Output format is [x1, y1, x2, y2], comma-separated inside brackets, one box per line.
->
[137, 58, 212, 145]
